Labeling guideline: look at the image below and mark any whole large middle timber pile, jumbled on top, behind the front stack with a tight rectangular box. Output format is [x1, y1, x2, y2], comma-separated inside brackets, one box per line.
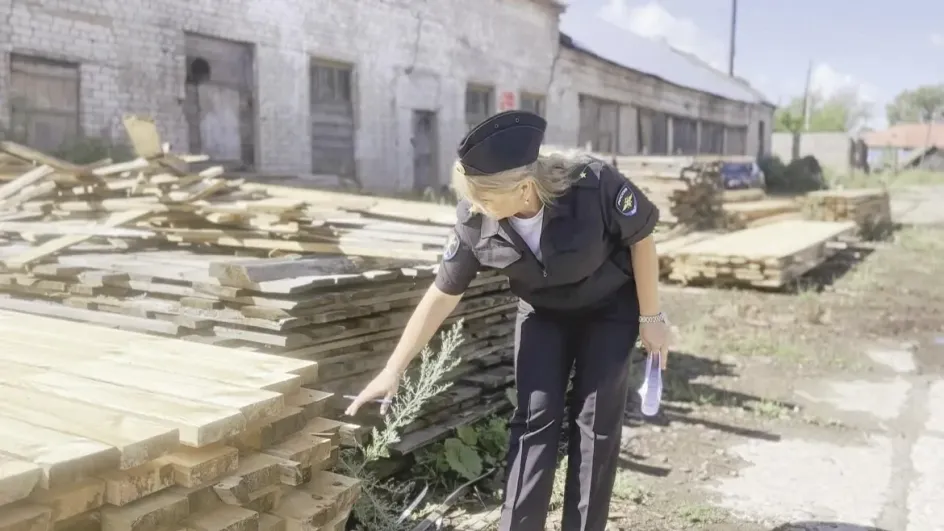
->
[0, 118, 515, 454]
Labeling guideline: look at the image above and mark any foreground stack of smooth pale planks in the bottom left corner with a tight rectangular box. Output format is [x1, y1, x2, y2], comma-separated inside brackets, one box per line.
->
[0, 312, 359, 531]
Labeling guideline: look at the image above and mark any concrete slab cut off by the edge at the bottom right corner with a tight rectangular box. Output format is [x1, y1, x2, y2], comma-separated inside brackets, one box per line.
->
[907, 436, 944, 531]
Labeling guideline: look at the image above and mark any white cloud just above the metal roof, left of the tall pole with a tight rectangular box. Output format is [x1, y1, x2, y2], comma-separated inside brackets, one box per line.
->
[599, 0, 727, 70]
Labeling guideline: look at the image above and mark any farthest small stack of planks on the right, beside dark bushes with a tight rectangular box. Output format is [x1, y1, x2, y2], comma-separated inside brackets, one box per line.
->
[803, 188, 892, 236]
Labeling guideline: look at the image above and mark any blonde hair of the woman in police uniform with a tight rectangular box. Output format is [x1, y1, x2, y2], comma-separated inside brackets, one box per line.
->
[452, 147, 593, 213]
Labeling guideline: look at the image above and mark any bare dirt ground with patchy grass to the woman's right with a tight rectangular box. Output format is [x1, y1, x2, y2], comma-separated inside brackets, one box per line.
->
[440, 227, 944, 531]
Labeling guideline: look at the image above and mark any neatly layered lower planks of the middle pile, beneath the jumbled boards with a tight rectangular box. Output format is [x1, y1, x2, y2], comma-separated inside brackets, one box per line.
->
[0, 246, 515, 454]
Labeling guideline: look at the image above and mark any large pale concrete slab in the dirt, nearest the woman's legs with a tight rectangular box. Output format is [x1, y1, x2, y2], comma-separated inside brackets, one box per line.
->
[711, 436, 893, 529]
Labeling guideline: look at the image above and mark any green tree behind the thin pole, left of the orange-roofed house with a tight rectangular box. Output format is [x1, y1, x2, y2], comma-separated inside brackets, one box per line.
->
[774, 89, 872, 133]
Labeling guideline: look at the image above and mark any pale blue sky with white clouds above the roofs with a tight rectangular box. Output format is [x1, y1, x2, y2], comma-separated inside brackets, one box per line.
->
[564, 0, 944, 127]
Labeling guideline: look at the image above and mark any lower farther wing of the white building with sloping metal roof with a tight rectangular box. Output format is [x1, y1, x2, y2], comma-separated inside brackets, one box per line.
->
[548, 2, 774, 160]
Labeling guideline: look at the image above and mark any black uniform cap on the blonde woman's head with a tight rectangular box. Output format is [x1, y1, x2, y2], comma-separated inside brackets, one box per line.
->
[459, 111, 547, 175]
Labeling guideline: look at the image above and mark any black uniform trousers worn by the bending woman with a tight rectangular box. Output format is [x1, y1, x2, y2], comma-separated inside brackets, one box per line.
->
[499, 283, 639, 531]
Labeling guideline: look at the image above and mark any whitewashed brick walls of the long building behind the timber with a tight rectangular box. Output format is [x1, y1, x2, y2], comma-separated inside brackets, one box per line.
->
[0, 0, 769, 190]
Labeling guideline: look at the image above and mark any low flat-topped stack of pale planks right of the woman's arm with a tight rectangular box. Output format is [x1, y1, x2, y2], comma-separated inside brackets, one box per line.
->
[659, 220, 856, 288]
